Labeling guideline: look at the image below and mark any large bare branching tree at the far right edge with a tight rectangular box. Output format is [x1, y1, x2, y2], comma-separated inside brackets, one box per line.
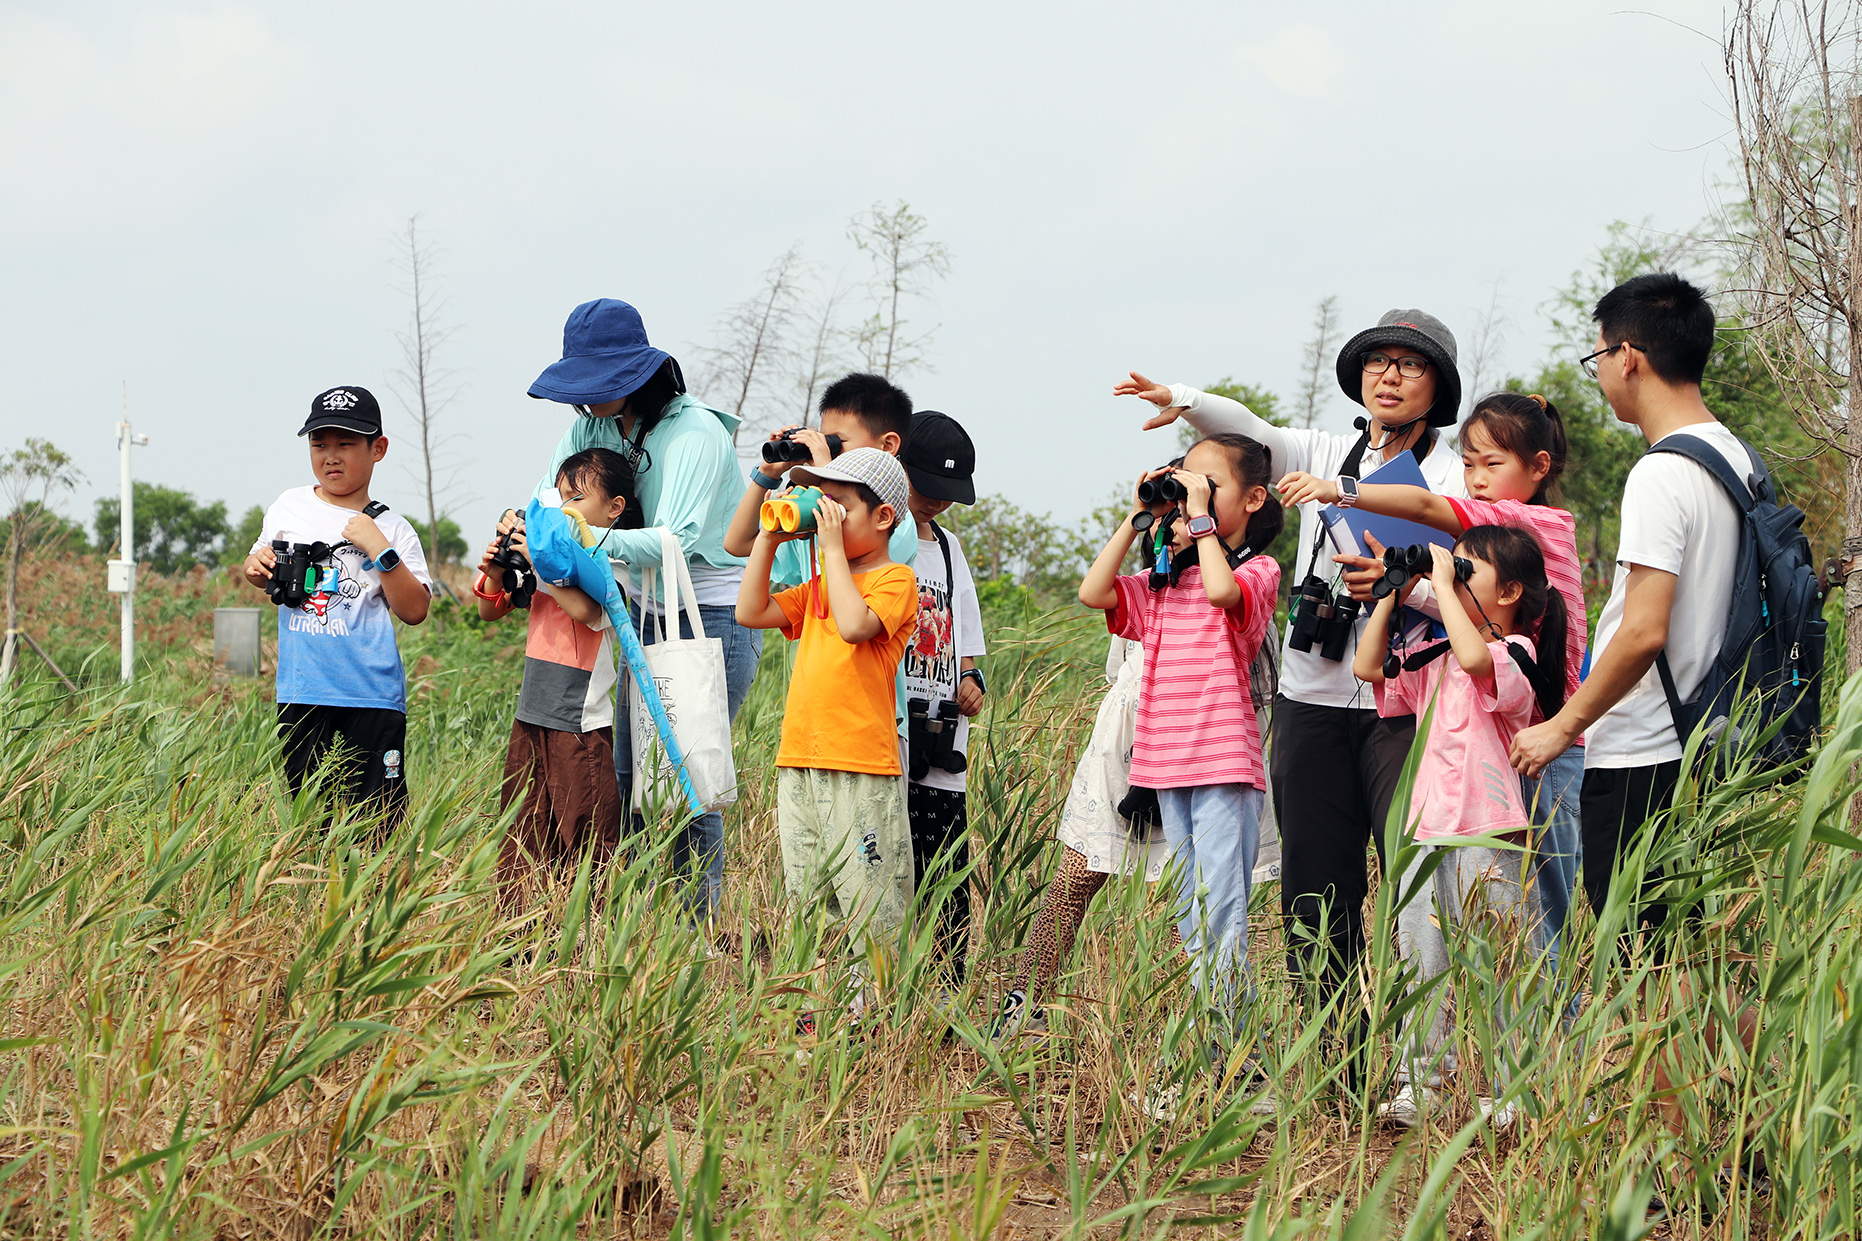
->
[1724, 0, 1862, 673]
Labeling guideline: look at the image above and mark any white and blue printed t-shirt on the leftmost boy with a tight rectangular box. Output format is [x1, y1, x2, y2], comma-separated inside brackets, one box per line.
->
[251, 486, 434, 712]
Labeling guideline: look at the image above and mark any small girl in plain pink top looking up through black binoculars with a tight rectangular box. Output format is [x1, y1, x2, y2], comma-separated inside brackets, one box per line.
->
[1352, 525, 1566, 1124]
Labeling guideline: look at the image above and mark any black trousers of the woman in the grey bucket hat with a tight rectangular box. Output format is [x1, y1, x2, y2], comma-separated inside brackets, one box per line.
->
[1268, 697, 1415, 1002]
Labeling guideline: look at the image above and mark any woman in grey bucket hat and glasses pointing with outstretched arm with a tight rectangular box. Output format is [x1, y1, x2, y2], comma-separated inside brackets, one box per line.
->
[1112, 309, 1467, 1073]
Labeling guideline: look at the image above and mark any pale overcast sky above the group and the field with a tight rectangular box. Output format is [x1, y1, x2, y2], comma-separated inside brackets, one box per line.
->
[0, 0, 1730, 539]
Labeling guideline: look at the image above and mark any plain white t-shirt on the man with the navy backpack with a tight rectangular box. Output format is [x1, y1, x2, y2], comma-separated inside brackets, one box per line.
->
[1585, 423, 1752, 768]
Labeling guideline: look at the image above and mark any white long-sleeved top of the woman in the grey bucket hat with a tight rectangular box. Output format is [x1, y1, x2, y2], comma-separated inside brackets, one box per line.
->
[1169, 384, 1467, 710]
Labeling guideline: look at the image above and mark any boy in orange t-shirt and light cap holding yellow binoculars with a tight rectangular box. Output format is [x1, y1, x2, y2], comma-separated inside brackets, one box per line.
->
[737, 447, 918, 946]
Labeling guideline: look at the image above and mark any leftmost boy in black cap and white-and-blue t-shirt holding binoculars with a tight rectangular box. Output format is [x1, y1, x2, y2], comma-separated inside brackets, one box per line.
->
[246, 384, 432, 827]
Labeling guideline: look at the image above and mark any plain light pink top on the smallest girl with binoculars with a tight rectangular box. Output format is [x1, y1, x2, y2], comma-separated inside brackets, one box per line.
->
[1378, 635, 1536, 840]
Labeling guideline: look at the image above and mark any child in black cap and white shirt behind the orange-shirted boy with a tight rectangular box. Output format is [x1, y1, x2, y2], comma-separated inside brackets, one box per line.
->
[899, 410, 985, 988]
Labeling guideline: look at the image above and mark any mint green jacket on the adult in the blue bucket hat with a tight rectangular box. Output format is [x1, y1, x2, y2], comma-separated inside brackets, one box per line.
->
[536, 395, 747, 587]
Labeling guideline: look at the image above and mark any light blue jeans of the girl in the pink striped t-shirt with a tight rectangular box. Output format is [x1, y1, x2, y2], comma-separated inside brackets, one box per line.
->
[1158, 784, 1266, 1012]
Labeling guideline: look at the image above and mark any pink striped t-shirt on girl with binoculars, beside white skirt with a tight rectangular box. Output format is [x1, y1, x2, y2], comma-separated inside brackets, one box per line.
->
[1106, 555, 1279, 788]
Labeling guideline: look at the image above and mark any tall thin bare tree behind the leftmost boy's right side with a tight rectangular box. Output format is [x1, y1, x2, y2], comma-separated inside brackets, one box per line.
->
[393, 212, 460, 596]
